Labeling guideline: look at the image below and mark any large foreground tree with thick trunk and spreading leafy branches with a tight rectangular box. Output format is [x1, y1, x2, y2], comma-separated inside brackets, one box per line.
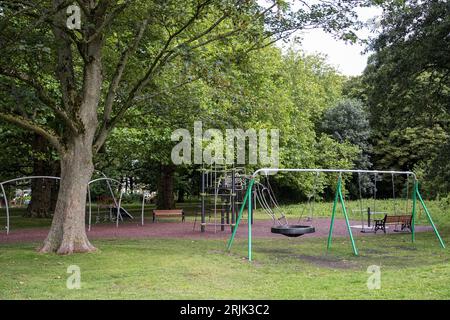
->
[0, 0, 370, 254]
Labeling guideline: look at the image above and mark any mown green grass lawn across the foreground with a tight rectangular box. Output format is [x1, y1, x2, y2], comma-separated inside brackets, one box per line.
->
[0, 202, 450, 299]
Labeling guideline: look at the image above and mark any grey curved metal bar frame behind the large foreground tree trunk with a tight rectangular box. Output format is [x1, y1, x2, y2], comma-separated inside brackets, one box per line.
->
[0, 172, 133, 234]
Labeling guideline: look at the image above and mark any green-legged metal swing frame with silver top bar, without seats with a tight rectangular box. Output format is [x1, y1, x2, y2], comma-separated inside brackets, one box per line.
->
[227, 169, 445, 261]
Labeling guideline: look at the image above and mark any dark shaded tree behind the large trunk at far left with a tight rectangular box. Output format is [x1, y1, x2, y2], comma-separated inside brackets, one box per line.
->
[0, 79, 59, 218]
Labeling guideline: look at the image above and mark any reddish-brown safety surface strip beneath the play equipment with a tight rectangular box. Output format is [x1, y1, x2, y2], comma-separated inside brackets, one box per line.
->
[0, 218, 432, 243]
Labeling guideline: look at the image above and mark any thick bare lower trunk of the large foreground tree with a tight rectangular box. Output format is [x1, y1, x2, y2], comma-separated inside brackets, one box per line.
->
[40, 137, 95, 254]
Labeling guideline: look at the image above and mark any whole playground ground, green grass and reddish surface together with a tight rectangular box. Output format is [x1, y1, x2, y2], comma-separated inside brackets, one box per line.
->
[0, 170, 450, 299]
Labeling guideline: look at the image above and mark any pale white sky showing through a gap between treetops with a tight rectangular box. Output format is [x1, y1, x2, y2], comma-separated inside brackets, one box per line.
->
[284, 8, 381, 76]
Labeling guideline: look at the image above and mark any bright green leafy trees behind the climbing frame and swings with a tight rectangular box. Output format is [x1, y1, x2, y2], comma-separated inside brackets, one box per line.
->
[101, 46, 358, 206]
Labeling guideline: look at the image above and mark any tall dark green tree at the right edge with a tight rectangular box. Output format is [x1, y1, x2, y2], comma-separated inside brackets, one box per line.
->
[360, 0, 450, 194]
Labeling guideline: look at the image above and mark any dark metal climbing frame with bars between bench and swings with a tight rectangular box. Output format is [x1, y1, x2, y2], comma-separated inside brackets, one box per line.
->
[194, 165, 248, 232]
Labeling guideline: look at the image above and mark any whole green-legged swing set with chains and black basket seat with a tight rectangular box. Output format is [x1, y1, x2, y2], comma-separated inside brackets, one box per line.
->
[227, 168, 445, 261]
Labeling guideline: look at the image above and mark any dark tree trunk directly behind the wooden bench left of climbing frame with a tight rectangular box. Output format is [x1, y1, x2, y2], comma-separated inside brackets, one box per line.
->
[156, 165, 175, 210]
